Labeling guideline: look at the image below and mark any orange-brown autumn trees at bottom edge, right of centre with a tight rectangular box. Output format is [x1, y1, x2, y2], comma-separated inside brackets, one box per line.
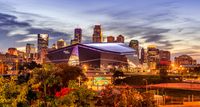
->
[97, 87, 156, 107]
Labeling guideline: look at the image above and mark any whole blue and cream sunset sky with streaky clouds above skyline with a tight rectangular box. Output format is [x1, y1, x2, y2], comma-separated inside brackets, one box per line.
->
[0, 0, 200, 59]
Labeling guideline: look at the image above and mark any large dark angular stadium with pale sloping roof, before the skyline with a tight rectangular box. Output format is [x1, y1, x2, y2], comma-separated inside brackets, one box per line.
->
[47, 43, 139, 70]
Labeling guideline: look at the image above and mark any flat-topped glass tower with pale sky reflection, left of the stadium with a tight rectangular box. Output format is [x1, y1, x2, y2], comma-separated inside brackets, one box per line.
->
[38, 34, 49, 53]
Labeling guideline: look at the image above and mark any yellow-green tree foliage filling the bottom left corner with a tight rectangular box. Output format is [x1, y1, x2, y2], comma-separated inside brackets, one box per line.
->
[0, 76, 28, 107]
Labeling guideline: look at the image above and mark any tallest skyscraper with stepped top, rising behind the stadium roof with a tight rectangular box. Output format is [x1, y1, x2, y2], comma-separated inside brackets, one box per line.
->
[92, 25, 103, 43]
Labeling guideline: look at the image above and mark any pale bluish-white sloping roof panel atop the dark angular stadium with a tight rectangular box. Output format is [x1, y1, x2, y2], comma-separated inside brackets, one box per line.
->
[83, 43, 135, 53]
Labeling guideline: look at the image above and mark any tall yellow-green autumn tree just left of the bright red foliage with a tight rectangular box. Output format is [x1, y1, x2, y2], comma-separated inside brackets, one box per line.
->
[29, 64, 62, 106]
